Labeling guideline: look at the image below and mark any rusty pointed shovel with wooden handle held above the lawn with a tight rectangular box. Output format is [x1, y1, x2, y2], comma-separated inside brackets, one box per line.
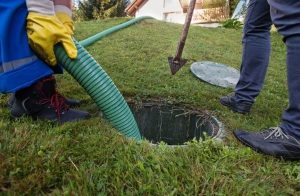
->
[168, 0, 196, 75]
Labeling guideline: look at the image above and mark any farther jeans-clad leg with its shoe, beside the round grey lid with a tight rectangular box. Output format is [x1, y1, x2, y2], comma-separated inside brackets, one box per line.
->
[220, 0, 272, 113]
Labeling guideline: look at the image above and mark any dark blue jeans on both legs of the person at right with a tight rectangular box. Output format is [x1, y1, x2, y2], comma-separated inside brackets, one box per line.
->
[235, 0, 300, 138]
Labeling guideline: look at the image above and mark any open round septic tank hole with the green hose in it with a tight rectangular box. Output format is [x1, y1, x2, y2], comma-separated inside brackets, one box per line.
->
[128, 102, 224, 145]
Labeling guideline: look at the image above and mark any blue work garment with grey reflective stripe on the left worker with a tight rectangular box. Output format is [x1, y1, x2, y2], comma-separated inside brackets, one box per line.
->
[0, 0, 53, 93]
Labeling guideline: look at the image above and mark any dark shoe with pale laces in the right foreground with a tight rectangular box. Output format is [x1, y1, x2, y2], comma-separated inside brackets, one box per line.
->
[234, 127, 300, 160]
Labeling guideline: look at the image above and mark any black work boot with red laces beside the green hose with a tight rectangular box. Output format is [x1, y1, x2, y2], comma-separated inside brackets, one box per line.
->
[11, 76, 90, 123]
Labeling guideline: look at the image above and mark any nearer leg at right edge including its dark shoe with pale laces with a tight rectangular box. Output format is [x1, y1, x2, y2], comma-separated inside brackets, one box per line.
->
[234, 0, 300, 160]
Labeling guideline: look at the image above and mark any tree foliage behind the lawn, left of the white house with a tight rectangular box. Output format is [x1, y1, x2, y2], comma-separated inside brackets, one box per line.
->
[77, 0, 129, 20]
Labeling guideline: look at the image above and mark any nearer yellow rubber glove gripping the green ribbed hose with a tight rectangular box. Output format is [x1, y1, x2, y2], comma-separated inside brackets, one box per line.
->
[27, 12, 77, 66]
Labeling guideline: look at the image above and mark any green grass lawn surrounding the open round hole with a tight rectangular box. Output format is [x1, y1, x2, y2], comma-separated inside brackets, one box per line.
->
[0, 18, 300, 195]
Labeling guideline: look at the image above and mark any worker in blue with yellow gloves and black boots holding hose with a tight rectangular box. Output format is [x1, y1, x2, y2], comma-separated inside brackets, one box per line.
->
[0, 0, 89, 123]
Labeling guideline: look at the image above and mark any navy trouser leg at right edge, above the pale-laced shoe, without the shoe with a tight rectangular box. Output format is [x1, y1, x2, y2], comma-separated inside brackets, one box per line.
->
[269, 0, 300, 140]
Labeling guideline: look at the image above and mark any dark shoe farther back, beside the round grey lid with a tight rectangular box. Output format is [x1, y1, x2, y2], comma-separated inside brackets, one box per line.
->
[220, 93, 252, 114]
